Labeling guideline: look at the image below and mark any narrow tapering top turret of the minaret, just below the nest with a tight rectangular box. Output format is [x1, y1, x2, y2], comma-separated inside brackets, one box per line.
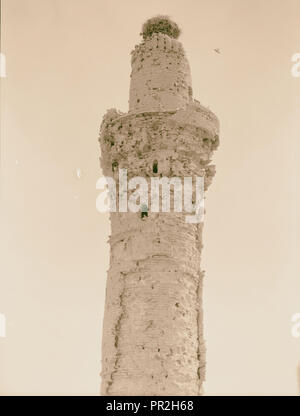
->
[129, 33, 192, 111]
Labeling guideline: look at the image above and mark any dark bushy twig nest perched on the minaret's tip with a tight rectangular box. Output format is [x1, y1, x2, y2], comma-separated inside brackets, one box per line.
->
[141, 16, 181, 39]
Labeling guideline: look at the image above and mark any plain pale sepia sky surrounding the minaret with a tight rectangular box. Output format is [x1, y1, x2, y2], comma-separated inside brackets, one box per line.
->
[0, 0, 300, 395]
